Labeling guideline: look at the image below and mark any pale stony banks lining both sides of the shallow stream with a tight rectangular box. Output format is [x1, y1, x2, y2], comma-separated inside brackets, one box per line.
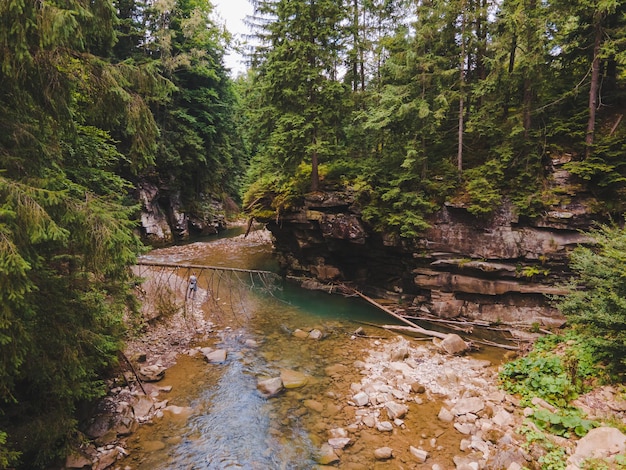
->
[66, 298, 626, 470]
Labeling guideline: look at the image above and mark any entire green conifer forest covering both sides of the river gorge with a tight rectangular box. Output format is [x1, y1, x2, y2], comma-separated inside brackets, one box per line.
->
[0, 0, 626, 468]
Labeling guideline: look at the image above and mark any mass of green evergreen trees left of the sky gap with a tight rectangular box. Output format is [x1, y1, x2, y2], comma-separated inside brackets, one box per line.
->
[0, 0, 245, 469]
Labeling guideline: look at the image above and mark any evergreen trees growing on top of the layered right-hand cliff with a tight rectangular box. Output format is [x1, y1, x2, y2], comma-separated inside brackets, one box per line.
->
[244, 0, 626, 231]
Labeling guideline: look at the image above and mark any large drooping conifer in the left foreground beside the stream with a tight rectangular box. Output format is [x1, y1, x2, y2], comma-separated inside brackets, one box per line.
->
[0, 0, 154, 468]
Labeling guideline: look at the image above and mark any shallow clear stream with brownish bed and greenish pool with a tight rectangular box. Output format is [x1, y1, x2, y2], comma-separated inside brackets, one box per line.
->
[122, 227, 502, 470]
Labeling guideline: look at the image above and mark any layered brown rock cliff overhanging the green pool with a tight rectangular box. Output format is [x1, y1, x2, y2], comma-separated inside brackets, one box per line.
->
[267, 180, 589, 326]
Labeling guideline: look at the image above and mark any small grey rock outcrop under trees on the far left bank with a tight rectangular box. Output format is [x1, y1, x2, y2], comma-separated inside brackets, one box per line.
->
[137, 182, 226, 245]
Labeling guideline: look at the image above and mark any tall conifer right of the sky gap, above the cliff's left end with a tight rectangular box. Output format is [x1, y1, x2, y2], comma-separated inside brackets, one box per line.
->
[247, 0, 346, 191]
